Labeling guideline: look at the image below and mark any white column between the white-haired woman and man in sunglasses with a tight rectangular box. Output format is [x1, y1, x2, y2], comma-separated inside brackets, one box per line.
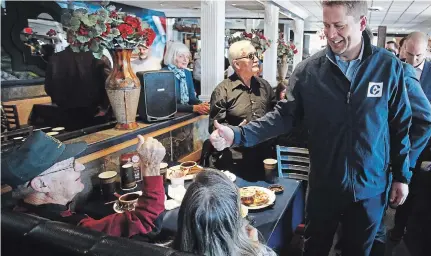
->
[199, 0, 225, 101]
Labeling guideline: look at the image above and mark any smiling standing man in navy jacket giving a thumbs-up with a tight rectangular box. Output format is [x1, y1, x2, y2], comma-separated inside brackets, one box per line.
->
[210, 1, 426, 256]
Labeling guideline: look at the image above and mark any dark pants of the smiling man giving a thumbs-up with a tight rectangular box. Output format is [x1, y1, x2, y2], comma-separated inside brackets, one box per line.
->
[304, 190, 387, 256]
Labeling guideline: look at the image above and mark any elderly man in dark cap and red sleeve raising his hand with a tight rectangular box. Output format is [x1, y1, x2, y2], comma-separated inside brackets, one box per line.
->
[1, 131, 166, 237]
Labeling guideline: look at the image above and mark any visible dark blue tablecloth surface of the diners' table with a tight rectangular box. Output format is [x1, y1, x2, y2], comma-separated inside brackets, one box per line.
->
[77, 173, 301, 241]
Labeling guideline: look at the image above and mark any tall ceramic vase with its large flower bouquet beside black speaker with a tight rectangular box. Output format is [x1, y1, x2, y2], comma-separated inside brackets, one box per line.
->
[63, 5, 156, 129]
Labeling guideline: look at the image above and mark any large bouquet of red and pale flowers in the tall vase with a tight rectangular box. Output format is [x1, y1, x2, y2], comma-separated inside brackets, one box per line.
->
[62, 5, 156, 58]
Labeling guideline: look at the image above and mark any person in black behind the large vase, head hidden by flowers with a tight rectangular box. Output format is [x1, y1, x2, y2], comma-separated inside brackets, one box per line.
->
[41, 32, 110, 130]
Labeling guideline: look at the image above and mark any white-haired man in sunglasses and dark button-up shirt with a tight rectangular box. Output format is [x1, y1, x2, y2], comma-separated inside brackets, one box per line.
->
[209, 40, 276, 180]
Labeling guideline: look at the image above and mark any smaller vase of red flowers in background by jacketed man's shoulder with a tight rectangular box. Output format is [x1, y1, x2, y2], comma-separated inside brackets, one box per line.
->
[277, 33, 298, 81]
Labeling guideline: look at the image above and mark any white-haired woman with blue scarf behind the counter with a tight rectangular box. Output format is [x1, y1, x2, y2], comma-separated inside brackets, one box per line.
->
[163, 42, 209, 115]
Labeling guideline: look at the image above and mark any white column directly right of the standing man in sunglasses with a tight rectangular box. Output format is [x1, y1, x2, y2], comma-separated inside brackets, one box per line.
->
[263, 3, 280, 87]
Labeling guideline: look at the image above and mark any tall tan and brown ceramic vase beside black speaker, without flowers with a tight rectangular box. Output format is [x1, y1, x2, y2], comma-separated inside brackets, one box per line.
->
[105, 49, 141, 130]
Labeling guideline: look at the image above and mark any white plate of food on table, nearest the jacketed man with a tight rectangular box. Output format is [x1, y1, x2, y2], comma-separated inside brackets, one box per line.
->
[239, 186, 275, 210]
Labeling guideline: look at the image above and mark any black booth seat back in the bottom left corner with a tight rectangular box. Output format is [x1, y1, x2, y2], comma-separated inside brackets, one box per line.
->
[1, 209, 192, 256]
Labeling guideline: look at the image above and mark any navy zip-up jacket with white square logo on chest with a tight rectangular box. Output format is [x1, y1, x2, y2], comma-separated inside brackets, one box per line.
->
[231, 35, 412, 201]
